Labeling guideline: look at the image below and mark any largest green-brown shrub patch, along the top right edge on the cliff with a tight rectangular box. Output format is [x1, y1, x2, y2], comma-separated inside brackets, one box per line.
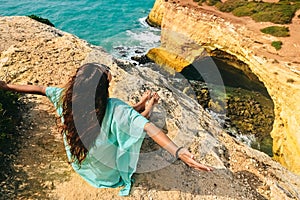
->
[216, 0, 300, 24]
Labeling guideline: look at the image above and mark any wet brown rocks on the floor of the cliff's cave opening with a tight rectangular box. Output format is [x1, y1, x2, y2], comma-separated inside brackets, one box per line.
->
[190, 81, 274, 156]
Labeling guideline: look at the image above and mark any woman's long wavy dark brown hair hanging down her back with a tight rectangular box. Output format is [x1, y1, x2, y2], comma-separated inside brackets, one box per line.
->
[62, 63, 109, 164]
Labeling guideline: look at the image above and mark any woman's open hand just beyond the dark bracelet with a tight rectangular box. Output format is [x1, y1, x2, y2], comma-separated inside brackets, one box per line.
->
[178, 148, 213, 171]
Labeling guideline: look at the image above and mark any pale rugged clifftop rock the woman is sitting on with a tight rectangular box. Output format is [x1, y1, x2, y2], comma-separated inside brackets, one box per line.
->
[0, 17, 300, 199]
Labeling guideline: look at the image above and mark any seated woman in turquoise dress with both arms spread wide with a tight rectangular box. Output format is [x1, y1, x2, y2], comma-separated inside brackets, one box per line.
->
[0, 63, 212, 196]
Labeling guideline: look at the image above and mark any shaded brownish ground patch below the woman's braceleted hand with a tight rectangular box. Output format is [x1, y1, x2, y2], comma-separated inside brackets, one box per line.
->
[133, 161, 266, 200]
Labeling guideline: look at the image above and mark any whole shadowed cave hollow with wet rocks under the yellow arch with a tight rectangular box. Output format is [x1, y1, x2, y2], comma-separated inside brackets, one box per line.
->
[181, 56, 274, 156]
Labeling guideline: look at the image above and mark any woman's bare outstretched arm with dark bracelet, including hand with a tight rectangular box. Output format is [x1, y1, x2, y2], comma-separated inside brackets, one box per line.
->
[144, 123, 213, 171]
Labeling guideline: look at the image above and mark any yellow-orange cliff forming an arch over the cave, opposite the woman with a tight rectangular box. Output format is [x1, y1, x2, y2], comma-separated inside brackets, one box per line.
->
[148, 0, 300, 174]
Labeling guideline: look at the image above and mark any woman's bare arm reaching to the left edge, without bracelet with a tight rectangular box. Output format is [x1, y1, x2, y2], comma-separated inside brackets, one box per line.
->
[0, 80, 46, 95]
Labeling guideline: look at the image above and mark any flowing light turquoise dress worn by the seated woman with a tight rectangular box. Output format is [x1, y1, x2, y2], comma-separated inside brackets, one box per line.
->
[46, 87, 149, 196]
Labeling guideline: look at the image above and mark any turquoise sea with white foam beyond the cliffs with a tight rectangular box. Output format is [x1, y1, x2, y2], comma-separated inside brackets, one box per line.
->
[0, 0, 160, 59]
